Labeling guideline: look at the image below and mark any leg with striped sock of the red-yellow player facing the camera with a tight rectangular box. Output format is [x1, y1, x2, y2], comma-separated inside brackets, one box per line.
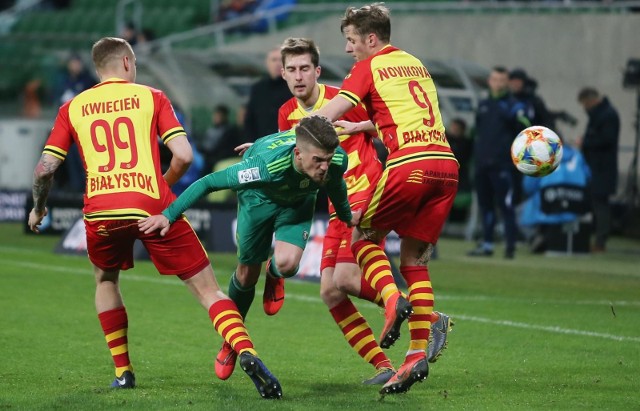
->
[320, 224, 395, 385]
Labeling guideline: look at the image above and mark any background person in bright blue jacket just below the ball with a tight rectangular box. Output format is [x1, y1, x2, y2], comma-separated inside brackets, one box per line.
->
[520, 142, 591, 253]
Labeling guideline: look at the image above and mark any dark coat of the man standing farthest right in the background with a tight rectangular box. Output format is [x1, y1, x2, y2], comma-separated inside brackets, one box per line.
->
[582, 97, 620, 196]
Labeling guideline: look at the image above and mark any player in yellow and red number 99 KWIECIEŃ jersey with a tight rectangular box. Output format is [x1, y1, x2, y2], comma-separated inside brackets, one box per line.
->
[28, 37, 282, 398]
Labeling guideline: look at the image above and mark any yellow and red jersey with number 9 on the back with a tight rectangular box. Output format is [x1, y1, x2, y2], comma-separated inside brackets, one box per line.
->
[339, 45, 453, 164]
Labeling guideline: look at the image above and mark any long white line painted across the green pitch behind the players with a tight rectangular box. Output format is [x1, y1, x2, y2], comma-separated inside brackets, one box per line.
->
[5, 261, 640, 343]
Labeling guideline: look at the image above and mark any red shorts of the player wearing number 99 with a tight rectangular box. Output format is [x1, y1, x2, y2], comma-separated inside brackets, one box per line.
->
[85, 218, 210, 280]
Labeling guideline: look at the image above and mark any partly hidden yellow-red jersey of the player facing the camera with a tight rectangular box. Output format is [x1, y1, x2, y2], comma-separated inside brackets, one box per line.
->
[278, 84, 382, 218]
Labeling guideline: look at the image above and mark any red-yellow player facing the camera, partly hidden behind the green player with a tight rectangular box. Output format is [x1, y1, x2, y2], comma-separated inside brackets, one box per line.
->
[278, 38, 395, 385]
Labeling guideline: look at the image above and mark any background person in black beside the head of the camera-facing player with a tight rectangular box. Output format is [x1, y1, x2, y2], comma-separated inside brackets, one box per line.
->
[244, 47, 291, 141]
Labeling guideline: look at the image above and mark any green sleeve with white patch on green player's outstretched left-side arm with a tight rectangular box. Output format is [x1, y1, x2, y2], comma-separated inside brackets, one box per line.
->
[162, 157, 271, 223]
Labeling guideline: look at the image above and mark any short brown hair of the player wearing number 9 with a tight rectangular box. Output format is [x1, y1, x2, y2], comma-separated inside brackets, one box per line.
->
[340, 3, 391, 43]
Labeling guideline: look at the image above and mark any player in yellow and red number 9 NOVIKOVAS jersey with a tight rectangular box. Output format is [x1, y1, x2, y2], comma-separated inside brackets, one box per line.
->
[318, 3, 458, 394]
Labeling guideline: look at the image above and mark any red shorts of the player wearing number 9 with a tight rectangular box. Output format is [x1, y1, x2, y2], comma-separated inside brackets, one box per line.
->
[360, 159, 458, 244]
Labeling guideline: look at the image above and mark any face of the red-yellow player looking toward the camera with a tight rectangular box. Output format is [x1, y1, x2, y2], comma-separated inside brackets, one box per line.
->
[282, 54, 320, 107]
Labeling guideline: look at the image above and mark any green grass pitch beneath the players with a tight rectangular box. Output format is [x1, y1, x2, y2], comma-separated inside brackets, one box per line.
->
[0, 223, 640, 411]
